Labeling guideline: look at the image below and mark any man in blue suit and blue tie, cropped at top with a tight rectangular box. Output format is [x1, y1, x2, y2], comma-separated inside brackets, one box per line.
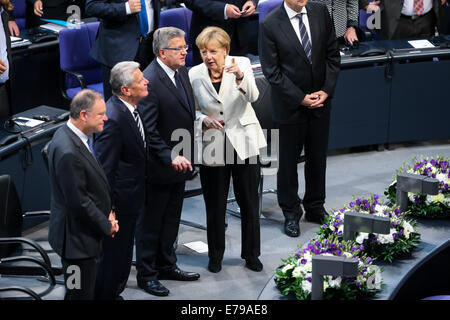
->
[86, 0, 161, 100]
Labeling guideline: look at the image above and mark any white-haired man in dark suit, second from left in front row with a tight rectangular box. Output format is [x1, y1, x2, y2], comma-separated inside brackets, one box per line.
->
[94, 61, 148, 300]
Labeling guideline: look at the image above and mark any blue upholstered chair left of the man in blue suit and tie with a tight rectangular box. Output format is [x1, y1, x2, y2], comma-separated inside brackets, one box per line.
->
[59, 22, 103, 100]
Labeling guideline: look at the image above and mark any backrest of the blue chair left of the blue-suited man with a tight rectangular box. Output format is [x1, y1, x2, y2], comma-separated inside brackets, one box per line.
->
[59, 21, 103, 89]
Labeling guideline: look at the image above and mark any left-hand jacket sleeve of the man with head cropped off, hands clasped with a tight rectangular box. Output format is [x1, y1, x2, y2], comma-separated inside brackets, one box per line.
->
[259, 20, 308, 106]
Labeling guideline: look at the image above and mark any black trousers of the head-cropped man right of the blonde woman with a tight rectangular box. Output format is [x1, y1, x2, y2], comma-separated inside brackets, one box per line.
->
[277, 107, 330, 221]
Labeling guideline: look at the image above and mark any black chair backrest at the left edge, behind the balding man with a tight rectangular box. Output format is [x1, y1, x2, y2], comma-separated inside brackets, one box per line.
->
[0, 175, 23, 258]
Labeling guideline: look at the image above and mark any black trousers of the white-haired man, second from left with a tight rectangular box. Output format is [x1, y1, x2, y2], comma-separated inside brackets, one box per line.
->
[95, 213, 138, 300]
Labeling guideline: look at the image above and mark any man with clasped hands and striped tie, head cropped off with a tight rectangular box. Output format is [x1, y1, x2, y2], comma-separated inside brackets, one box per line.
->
[259, 0, 340, 237]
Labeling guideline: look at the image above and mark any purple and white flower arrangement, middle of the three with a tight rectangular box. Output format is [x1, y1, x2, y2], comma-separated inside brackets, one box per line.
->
[318, 194, 420, 262]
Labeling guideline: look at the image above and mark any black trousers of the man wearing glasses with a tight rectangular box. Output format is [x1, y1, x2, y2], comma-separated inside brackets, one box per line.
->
[136, 181, 185, 283]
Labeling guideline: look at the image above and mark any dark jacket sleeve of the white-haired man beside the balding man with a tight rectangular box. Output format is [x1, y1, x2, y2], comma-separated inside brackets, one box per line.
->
[94, 118, 122, 205]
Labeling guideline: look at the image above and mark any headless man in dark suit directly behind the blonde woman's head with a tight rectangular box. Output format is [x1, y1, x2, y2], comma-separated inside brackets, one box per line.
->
[185, 0, 258, 65]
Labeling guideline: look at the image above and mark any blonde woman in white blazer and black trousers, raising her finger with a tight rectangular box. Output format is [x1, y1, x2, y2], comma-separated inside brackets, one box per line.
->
[189, 27, 267, 273]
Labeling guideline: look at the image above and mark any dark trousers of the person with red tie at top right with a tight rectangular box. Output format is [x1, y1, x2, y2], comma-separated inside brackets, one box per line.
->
[392, 9, 436, 39]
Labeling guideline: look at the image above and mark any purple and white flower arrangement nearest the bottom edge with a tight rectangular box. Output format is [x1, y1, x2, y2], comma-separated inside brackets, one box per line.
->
[275, 236, 382, 300]
